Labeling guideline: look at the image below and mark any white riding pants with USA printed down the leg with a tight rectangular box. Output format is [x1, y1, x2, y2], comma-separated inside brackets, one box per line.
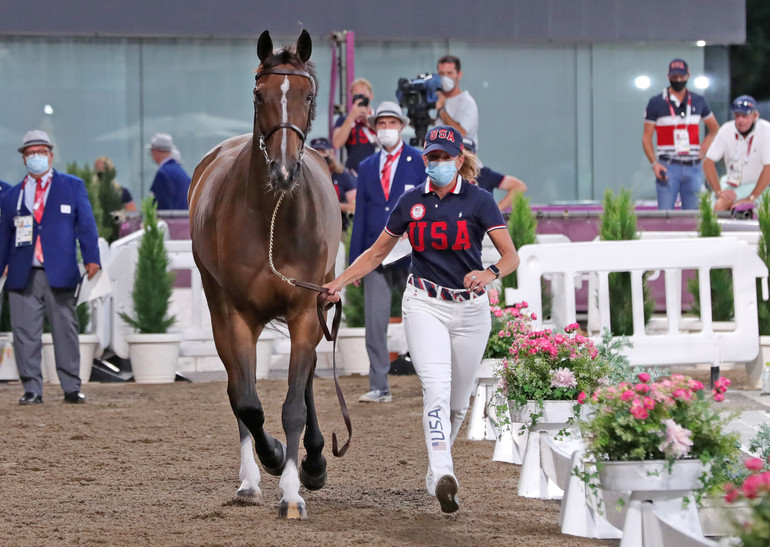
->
[402, 285, 491, 496]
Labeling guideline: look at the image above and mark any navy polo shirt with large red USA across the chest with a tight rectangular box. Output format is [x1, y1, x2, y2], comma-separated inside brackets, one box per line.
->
[385, 177, 506, 289]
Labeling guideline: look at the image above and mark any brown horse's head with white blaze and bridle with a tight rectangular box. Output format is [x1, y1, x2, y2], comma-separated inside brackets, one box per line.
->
[254, 30, 317, 191]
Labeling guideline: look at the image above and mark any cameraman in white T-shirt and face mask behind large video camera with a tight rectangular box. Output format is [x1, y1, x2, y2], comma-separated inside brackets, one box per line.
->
[436, 55, 479, 146]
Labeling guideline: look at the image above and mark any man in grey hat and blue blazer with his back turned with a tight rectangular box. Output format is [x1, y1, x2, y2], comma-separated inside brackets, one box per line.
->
[147, 133, 190, 211]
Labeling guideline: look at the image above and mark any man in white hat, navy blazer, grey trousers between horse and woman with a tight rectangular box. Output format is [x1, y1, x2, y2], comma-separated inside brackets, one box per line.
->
[349, 101, 425, 403]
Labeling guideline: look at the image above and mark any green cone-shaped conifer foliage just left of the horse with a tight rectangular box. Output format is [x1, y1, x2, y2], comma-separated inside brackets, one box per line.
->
[120, 196, 176, 334]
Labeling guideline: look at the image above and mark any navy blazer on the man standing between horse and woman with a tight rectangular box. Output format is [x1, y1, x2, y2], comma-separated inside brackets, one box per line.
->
[350, 144, 427, 263]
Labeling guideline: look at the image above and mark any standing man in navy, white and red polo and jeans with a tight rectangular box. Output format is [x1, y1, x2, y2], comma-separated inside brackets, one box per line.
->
[642, 59, 719, 209]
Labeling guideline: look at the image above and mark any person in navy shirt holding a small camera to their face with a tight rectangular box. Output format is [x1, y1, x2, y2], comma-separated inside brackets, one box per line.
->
[332, 78, 377, 173]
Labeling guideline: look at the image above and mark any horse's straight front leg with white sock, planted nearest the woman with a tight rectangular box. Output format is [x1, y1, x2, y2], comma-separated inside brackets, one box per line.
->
[278, 308, 320, 519]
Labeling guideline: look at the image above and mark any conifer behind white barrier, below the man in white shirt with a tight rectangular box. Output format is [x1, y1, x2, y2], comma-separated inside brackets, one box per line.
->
[687, 192, 735, 321]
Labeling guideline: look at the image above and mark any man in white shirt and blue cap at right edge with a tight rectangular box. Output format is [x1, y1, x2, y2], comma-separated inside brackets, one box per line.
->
[703, 95, 770, 211]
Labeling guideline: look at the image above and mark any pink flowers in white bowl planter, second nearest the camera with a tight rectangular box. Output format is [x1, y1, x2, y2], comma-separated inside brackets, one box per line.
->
[578, 374, 739, 498]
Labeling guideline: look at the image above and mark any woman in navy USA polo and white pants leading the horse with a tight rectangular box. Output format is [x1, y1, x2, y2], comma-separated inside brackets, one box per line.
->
[325, 125, 519, 513]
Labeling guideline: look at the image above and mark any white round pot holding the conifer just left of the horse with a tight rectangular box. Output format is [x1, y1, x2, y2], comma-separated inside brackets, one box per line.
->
[126, 334, 182, 384]
